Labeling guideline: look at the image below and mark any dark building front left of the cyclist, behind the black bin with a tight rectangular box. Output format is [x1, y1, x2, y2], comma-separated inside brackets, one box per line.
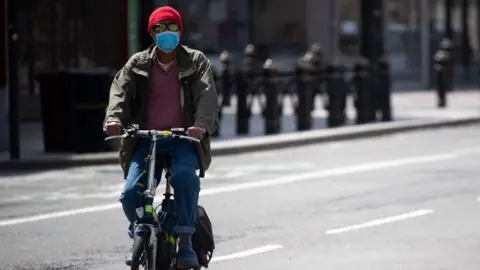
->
[0, 0, 129, 151]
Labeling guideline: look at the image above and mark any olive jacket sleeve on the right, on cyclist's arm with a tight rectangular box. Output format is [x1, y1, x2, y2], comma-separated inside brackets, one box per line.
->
[193, 53, 219, 134]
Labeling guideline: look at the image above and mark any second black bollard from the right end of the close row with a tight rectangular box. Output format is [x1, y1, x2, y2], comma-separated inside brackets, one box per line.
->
[353, 59, 374, 124]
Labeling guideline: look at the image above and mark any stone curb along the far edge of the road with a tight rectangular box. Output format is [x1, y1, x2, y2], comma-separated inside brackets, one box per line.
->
[0, 116, 480, 171]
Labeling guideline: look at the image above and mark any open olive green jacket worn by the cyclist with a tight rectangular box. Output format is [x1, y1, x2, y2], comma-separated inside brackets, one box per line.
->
[104, 45, 218, 178]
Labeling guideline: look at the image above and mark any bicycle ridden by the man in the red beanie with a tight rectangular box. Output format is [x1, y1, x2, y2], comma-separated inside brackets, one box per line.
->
[105, 125, 201, 270]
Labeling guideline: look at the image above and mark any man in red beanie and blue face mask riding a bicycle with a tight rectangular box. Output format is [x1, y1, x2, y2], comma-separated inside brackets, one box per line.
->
[104, 7, 218, 268]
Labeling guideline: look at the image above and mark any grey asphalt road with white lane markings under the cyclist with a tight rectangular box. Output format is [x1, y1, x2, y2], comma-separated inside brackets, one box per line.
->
[0, 126, 480, 270]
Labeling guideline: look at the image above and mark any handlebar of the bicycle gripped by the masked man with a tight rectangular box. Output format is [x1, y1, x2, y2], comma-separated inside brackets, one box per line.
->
[104, 127, 200, 143]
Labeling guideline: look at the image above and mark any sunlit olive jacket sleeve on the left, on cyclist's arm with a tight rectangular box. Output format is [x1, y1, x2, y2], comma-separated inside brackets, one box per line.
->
[104, 56, 136, 126]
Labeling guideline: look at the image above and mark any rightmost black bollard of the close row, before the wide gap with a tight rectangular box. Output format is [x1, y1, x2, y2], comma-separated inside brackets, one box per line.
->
[377, 57, 392, 122]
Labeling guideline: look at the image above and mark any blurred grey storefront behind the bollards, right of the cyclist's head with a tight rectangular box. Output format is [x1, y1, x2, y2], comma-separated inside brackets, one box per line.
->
[154, 0, 479, 85]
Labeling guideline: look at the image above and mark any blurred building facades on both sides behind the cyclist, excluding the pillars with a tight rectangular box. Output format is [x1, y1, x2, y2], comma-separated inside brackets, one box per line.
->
[0, 0, 480, 93]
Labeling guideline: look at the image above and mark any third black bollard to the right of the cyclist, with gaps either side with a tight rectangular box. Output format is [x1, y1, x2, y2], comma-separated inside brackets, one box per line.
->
[263, 59, 283, 135]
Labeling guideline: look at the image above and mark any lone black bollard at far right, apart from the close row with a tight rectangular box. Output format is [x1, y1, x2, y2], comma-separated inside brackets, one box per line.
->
[434, 50, 450, 108]
